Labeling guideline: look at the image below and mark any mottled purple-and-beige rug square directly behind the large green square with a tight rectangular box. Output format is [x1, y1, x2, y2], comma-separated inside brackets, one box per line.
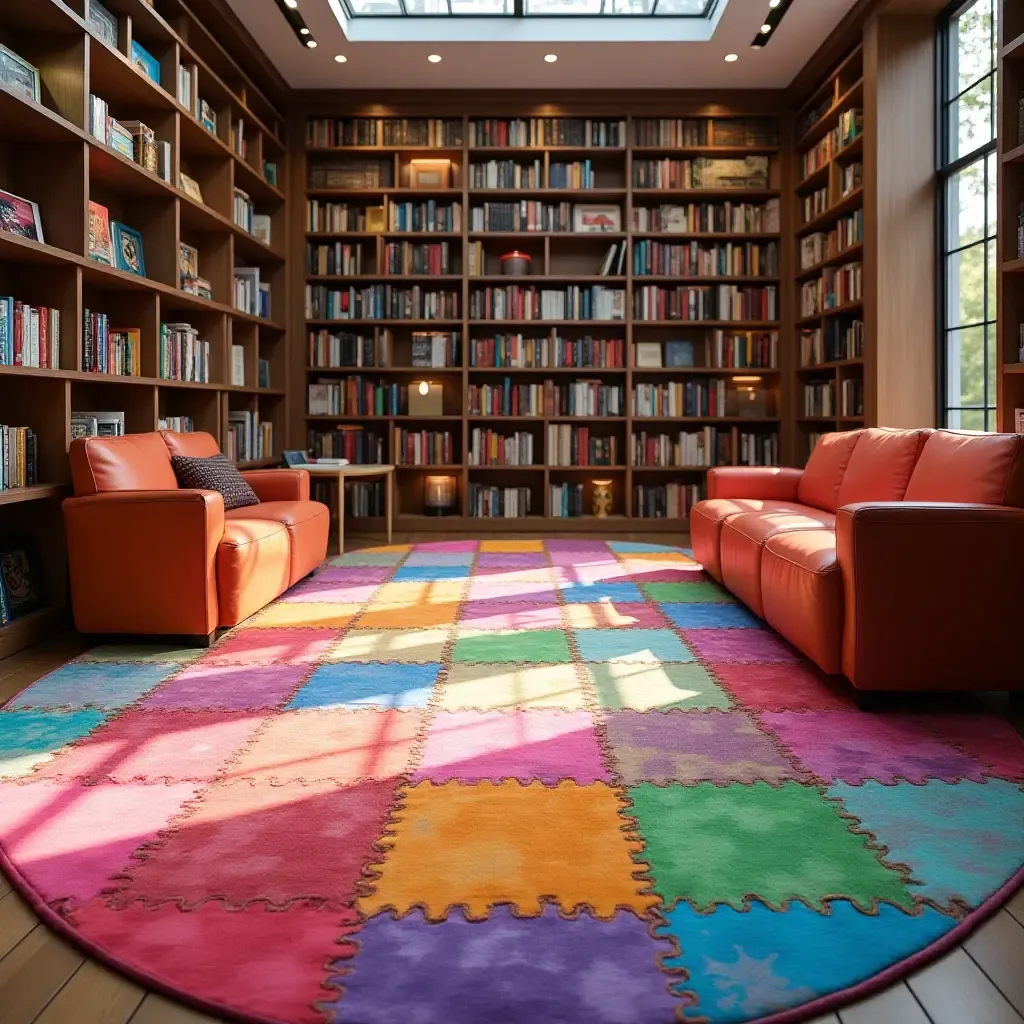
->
[604, 710, 808, 785]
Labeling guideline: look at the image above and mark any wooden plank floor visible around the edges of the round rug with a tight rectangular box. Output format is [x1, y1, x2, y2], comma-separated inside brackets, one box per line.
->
[0, 534, 1024, 1024]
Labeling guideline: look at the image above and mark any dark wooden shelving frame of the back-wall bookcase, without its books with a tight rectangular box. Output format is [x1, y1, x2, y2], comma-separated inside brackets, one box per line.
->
[291, 97, 788, 531]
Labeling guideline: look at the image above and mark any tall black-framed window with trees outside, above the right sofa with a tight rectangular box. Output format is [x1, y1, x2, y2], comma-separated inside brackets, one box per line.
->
[939, 0, 998, 430]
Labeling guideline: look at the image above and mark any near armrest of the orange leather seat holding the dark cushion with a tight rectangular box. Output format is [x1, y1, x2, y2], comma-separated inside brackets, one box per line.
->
[62, 489, 224, 637]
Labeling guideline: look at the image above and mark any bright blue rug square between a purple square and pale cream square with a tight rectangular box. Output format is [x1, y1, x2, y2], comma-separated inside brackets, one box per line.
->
[286, 662, 441, 711]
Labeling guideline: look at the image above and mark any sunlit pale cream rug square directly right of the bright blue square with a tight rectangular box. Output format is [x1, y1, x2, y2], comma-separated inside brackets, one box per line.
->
[439, 664, 586, 711]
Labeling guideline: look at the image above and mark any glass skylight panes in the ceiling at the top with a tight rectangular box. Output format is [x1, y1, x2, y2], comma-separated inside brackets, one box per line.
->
[341, 0, 716, 18]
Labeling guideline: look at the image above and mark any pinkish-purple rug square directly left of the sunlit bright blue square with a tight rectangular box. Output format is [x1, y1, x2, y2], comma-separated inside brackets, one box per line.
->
[139, 665, 310, 711]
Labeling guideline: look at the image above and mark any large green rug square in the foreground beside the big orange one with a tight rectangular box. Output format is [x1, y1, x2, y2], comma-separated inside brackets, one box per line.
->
[626, 782, 913, 911]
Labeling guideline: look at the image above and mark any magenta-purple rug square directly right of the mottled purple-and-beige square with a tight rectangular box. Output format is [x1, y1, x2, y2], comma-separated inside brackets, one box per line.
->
[761, 711, 984, 785]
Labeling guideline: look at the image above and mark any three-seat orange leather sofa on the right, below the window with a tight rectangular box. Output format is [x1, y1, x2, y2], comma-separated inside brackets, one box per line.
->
[690, 429, 1024, 690]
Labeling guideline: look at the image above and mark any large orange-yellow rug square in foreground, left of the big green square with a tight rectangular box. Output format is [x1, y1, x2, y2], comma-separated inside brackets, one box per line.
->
[359, 780, 658, 922]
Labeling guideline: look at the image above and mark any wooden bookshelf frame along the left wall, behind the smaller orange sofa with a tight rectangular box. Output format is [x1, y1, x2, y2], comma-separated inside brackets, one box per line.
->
[0, 0, 289, 658]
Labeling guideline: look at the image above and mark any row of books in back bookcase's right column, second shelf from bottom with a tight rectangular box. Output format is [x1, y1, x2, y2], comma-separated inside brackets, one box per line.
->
[630, 426, 778, 469]
